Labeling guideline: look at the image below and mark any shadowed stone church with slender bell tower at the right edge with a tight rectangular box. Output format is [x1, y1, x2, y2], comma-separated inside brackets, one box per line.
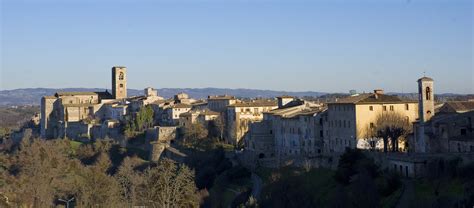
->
[410, 77, 474, 153]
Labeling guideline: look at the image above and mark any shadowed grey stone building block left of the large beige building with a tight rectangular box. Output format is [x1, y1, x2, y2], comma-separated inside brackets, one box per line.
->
[244, 97, 325, 167]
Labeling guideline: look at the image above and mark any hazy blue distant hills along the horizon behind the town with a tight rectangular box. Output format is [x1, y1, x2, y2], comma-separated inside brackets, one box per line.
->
[0, 88, 326, 106]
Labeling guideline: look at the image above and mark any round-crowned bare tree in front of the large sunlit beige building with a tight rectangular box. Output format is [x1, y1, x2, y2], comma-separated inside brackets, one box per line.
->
[375, 113, 411, 152]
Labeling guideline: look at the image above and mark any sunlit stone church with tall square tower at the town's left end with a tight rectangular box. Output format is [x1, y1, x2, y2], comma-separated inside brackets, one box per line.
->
[40, 67, 127, 139]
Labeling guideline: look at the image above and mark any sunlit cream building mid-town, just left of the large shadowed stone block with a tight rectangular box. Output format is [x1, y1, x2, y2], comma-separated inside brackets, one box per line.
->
[226, 100, 278, 145]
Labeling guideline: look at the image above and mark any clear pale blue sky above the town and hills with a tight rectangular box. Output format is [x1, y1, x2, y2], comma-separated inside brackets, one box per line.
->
[0, 0, 474, 93]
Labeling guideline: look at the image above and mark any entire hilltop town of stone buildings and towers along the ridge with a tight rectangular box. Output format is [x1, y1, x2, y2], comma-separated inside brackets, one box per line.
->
[1, 66, 474, 206]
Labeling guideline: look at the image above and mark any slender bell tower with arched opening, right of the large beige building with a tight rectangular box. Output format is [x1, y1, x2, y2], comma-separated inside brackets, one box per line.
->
[418, 77, 435, 123]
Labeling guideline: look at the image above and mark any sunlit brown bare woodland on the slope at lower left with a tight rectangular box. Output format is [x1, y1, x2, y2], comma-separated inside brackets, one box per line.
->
[0, 139, 200, 207]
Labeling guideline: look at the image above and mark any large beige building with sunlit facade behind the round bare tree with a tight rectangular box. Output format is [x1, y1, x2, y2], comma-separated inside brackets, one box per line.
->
[324, 90, 418, 153]
